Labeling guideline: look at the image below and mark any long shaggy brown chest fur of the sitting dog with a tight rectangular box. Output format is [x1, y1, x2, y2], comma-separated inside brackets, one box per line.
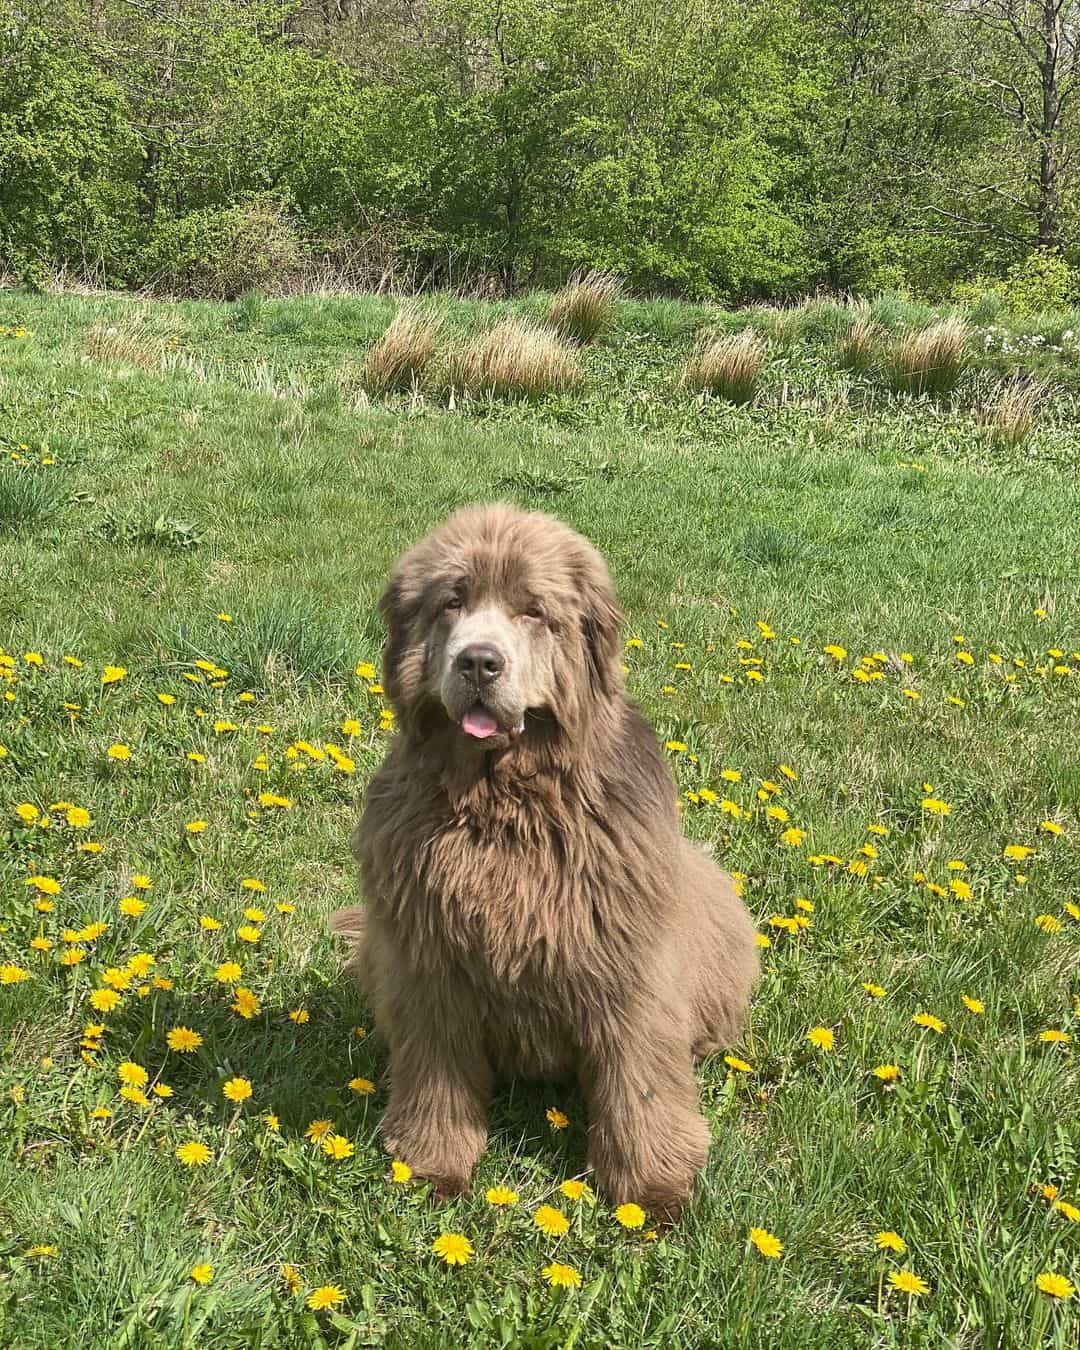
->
[358, 761, 670, 1003]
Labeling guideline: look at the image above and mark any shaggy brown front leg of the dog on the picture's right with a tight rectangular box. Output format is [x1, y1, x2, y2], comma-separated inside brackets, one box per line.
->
[579, 1006, 709, 1222]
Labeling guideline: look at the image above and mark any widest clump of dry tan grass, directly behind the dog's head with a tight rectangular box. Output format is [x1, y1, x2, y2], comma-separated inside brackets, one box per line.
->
[450, 317, 582, 398]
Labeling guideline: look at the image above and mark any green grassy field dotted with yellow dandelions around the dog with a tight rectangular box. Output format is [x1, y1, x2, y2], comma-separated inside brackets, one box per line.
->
[0, 293, 1080, 1350]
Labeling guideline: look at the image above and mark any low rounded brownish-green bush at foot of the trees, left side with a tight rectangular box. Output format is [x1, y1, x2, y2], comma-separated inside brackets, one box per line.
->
[142, 197, 300, 300]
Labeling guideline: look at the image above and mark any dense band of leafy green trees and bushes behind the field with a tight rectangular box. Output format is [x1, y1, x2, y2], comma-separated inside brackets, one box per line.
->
[0, 0, 1080, 298]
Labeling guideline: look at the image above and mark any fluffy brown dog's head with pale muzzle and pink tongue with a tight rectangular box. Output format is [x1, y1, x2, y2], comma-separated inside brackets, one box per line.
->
[379, 505, 622, 749]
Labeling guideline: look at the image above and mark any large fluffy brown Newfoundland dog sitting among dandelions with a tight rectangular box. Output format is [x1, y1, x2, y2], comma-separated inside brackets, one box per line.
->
[331, 505, 757, 1219]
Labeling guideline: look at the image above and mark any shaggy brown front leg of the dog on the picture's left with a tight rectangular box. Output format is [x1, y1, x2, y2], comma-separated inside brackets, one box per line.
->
[381, 991, 491, 1197]
